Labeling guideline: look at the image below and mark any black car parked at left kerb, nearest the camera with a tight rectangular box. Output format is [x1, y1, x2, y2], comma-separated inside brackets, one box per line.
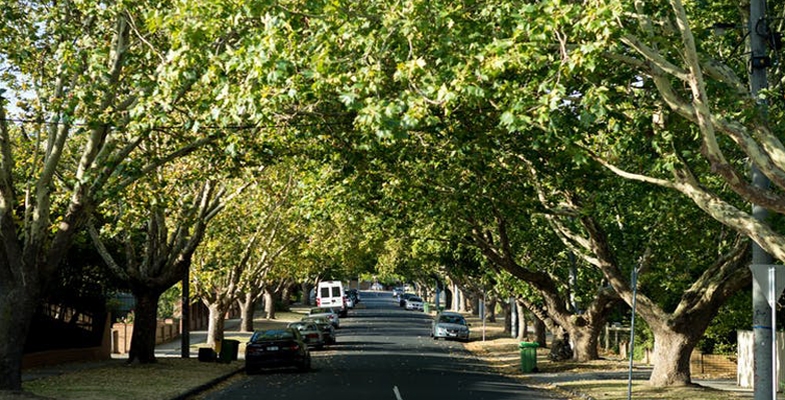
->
[245, 328, 311, 374]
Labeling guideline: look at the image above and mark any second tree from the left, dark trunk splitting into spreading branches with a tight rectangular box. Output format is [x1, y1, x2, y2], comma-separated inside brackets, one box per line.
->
[88, 154, 236, 363]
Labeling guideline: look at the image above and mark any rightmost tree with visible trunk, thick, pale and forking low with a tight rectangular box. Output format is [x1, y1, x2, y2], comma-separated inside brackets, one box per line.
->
[516, 148, 751, 386]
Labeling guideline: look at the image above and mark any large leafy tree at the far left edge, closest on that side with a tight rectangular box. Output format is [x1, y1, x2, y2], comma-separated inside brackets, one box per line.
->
[0, 1, 242, 390]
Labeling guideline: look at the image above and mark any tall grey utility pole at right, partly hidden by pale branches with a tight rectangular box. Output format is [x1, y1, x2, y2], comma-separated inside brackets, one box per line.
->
[747, 0, 778, 400]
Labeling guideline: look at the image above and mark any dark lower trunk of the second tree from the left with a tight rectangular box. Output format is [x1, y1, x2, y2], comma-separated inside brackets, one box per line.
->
[128, 287, 162, 364]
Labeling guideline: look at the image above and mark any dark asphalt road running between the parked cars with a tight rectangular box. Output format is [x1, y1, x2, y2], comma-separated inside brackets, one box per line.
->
[199, 292, 563, 400]
